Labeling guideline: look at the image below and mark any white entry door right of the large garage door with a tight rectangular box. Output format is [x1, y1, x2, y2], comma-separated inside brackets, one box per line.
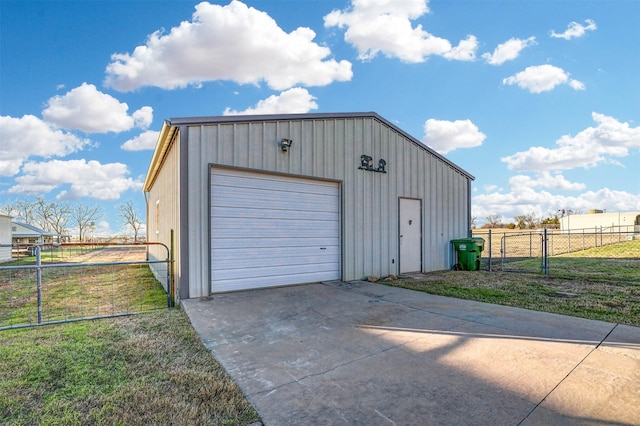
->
[399, 198, 422, 274]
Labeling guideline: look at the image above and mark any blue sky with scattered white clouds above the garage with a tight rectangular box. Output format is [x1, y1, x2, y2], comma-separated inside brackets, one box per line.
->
[0, 0, 640, 235]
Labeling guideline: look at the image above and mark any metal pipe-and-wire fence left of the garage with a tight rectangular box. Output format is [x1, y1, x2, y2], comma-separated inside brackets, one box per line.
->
[0, 243, 172, 330]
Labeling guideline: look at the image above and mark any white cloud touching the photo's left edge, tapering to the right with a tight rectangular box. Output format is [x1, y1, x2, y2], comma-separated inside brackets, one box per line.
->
[0, 115, 91, 176]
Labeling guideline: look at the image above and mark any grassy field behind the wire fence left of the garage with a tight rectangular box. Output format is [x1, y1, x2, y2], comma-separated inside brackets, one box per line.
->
[0, 247, 167, 328]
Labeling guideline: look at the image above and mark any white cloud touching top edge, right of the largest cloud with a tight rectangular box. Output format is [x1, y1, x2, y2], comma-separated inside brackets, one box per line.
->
[324, 0, 478, 63]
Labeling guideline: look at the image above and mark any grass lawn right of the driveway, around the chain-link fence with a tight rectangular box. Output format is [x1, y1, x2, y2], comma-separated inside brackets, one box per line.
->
[385, 241, 640, 326]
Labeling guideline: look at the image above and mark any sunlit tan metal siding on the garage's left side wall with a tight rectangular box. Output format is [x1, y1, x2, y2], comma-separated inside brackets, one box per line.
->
[147, 132, 182, 297]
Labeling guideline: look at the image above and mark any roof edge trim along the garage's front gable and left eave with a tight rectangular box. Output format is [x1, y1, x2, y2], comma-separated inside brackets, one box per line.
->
[142, 111, 475, 192]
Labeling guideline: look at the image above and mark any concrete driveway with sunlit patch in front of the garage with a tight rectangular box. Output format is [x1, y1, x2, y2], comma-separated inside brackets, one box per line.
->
[183, 282, 640, 425]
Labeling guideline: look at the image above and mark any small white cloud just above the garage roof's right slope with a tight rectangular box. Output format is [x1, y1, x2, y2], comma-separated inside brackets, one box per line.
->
[422, 118, 487, 154]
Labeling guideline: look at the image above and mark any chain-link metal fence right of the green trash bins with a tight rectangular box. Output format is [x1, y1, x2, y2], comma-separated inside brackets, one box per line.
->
[473, 227, 640, 274]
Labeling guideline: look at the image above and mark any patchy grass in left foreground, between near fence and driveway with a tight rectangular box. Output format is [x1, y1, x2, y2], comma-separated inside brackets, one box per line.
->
[0, 309, 259, 425]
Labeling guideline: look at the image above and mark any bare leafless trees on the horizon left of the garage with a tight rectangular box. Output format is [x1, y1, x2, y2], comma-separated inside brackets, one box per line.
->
[0, 196, 142, 242]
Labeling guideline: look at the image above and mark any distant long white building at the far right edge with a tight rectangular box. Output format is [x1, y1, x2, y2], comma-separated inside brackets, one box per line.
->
[560, 210, 640, 232]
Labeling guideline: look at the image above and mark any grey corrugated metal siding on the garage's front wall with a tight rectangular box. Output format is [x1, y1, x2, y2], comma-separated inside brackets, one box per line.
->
[184, 117, 469, 297]
